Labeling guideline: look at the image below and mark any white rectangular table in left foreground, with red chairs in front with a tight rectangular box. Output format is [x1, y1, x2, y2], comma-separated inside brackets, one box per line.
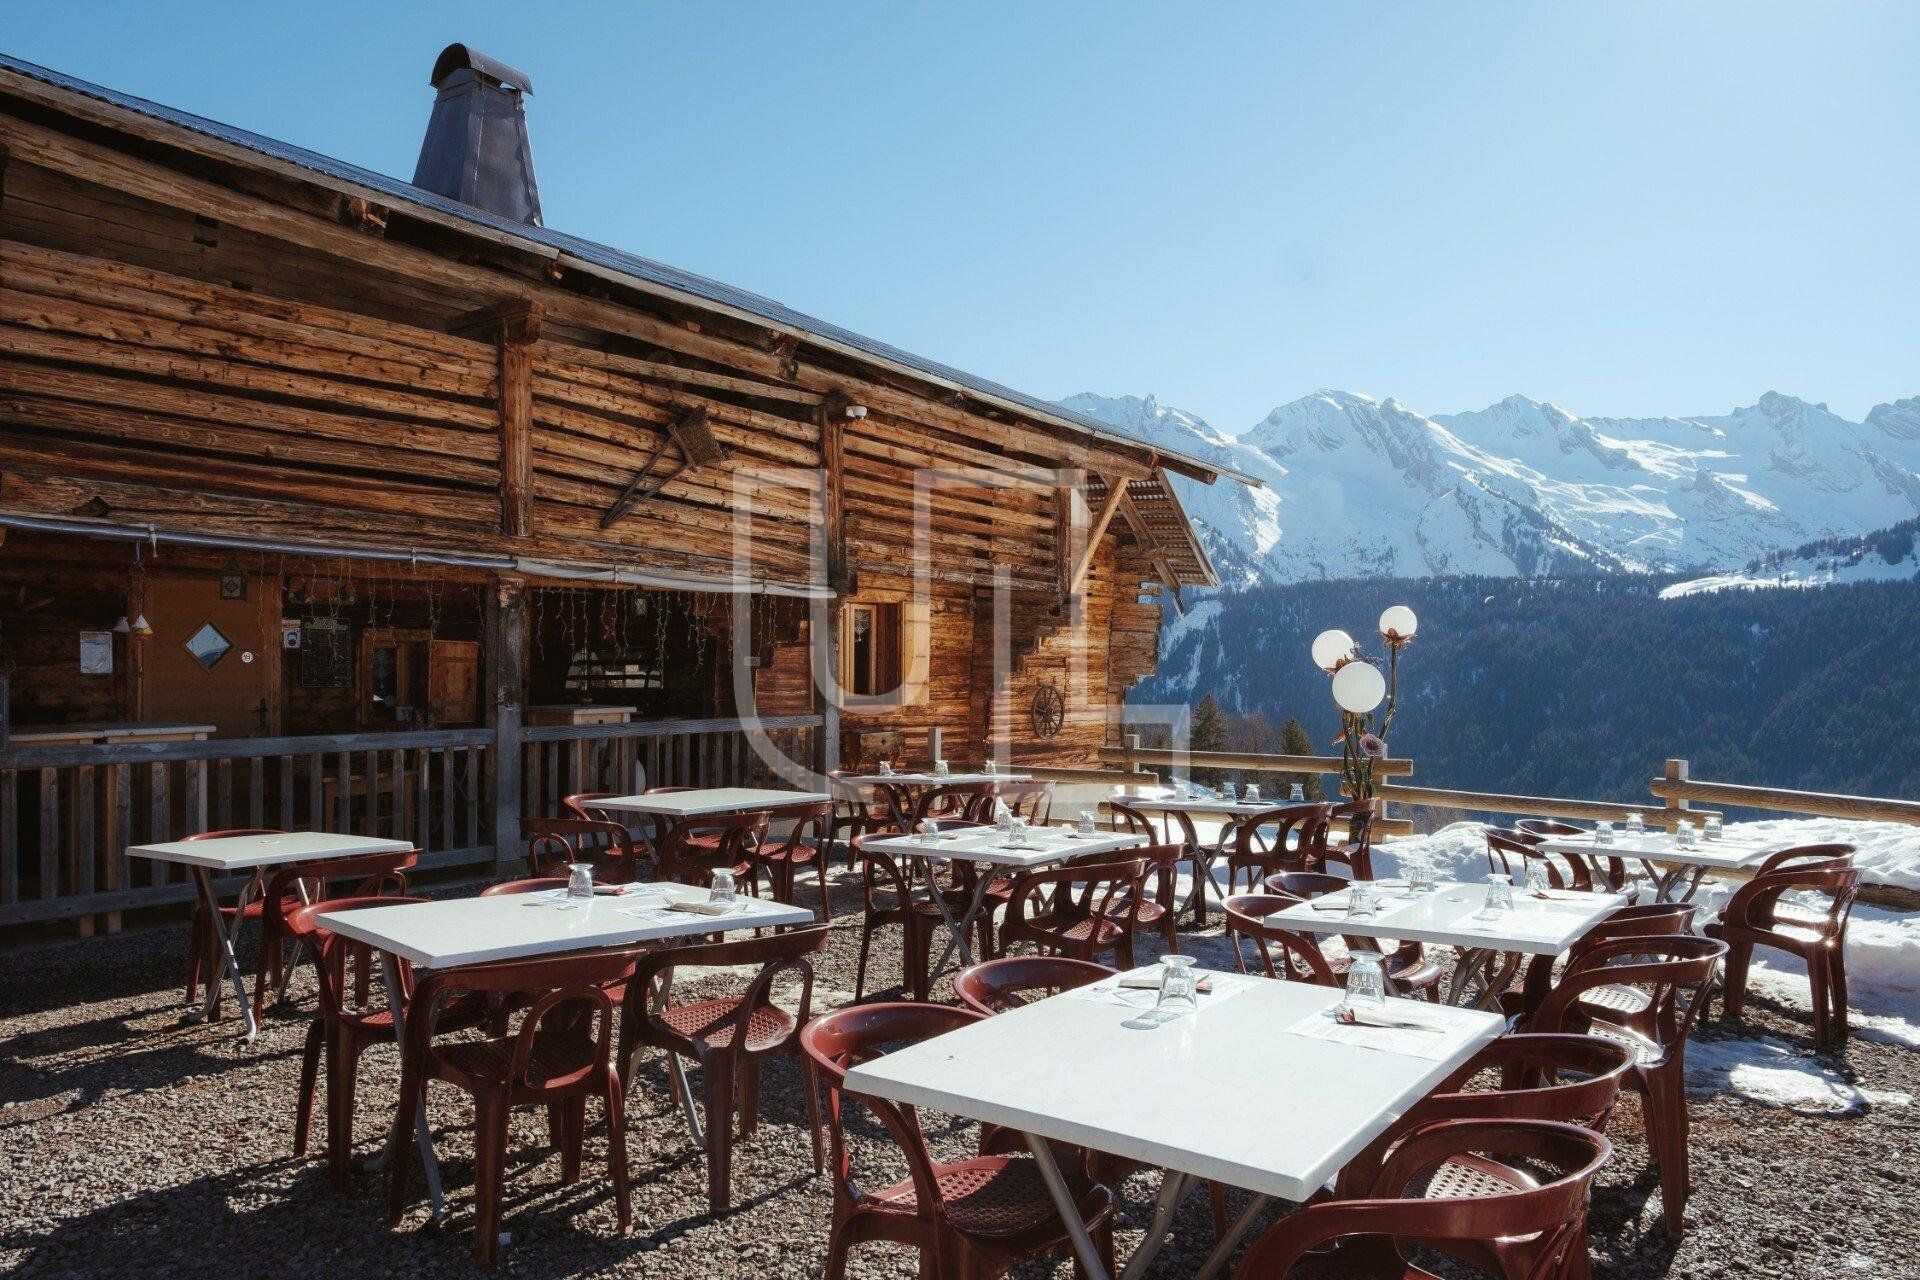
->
[319, 882, 814, 1219]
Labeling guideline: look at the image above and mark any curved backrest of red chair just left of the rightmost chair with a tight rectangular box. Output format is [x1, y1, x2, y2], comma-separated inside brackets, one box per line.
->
[1528, 935, 1728, 1055]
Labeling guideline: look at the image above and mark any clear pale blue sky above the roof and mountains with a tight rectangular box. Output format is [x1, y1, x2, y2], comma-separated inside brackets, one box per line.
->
[0, 0, 1920, 432]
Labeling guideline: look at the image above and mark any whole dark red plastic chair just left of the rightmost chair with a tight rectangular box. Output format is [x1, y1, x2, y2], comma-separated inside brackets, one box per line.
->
[1526, 936, 1726, 1236]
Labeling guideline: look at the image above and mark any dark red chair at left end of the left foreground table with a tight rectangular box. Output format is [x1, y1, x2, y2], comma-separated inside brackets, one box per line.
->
[286, 898, 486, 1194]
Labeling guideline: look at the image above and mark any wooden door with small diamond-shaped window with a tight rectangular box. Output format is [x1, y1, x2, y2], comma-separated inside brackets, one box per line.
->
[140, 574, 280, 737]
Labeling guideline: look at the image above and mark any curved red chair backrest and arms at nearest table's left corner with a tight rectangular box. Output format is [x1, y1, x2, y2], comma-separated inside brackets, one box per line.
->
[801, 1002, 983, 1219]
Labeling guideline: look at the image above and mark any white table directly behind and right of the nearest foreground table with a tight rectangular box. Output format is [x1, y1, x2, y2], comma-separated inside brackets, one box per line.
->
[1267, 883, 1626, 1007]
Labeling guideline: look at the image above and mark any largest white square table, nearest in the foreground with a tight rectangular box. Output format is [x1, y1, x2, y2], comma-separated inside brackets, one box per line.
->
[845, 975, 1505, 1280]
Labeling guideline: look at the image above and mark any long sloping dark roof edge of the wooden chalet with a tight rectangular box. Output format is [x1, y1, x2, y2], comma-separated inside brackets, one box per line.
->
[0, 54, 1258, 484]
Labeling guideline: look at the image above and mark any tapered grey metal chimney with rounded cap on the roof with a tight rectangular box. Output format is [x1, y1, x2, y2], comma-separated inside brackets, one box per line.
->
[413, 44, 540, 226]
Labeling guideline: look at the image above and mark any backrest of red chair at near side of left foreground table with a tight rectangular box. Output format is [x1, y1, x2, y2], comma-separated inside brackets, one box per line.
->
[407, 946, 639, 1102]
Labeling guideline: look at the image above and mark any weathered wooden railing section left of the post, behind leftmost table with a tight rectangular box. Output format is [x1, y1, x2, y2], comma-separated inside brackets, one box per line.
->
[0, 729, 493, 927]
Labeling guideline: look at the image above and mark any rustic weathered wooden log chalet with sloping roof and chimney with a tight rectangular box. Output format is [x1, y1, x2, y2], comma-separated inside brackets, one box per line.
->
[0, 46, 1244, 927]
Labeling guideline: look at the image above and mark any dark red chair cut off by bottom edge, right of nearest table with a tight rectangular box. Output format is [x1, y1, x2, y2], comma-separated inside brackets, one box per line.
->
[1235, 1121, 1613, 1280]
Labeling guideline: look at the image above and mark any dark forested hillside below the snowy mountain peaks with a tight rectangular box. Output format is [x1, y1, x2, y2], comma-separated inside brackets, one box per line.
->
[1131, 576, 1920, 800]
